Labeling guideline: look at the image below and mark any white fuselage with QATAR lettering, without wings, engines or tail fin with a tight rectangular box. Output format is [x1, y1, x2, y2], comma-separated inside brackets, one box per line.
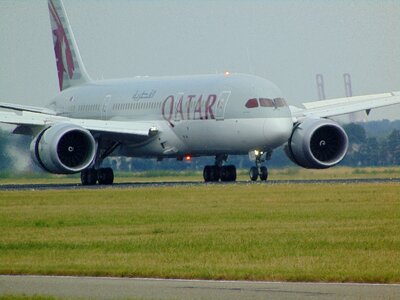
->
[48, 74, 293, 158]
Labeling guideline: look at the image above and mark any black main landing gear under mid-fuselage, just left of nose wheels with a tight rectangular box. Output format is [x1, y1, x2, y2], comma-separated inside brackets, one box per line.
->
[203, 155, 236, 182]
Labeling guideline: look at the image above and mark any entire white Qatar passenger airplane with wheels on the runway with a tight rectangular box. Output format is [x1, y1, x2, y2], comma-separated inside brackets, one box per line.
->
[0, 0, 400, 185]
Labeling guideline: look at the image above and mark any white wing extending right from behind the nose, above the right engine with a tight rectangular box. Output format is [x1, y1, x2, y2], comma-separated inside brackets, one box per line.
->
[290, 92, 400, 122]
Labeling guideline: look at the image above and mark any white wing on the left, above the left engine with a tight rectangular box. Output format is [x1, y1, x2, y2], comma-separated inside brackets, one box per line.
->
[0, 103, 158, 142]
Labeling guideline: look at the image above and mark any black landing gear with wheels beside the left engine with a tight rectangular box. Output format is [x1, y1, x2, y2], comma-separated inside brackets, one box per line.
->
[81, 140, 120, 185]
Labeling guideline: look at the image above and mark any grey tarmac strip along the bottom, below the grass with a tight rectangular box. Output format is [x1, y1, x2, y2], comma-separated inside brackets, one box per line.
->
[0, 276, 400, 300]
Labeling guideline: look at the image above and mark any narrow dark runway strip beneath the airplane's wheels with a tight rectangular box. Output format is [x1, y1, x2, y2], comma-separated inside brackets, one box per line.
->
[0, 178, 400, 191]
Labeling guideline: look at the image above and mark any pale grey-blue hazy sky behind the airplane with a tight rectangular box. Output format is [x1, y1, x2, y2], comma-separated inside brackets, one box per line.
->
[0, 0, 400, 119]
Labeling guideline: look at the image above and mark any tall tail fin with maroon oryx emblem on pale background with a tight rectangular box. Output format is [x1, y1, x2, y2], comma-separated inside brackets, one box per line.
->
[48, 0, 90, 91]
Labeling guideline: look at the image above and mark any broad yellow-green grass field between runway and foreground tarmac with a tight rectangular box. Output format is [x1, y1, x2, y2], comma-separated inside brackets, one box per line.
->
[0, 183, 400, 283]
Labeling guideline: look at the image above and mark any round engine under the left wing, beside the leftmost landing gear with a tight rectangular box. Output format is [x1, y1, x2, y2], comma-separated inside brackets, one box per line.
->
[31, 123, 96, 174]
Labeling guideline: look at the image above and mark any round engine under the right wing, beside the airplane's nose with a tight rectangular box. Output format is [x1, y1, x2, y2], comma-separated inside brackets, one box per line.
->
[285, 119, 349, 169]
